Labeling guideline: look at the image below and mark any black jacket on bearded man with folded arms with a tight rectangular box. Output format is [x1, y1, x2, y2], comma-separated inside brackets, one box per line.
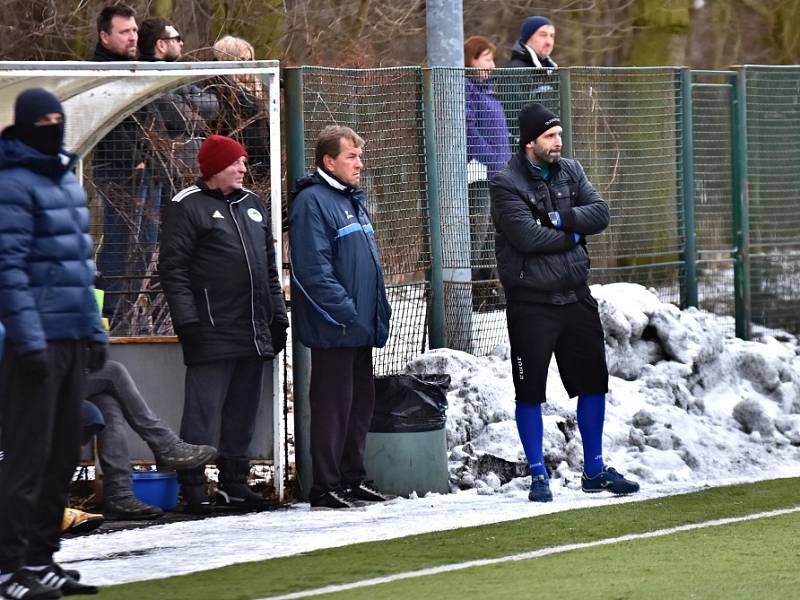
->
[489, 153, 610, 304]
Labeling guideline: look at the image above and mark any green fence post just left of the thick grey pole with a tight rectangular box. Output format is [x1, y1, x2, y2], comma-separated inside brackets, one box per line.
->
[422, 69, 447, 348]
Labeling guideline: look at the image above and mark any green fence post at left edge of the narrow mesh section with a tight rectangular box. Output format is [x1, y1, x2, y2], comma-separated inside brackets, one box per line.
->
[681, 67, 697, 306]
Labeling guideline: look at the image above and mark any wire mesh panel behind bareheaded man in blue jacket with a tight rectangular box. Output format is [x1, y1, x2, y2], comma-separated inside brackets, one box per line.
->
[302, 67, 430, 374]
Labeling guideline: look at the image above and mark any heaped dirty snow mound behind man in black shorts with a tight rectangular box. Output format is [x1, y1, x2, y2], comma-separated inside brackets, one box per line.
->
[405, 283, 800, 494]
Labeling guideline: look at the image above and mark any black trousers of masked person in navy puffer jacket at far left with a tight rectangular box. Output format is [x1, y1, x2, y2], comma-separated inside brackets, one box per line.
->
[0, 340, 86, 573]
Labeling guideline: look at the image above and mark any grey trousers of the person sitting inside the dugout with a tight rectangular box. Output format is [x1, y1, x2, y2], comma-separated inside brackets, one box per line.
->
[86, 360, 179, 499]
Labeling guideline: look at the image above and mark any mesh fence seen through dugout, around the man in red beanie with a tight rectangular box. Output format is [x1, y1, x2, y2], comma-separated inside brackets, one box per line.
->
[84, 75, 270, 337]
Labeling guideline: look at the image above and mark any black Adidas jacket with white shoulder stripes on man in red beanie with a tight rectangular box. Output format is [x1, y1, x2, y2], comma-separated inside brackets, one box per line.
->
[158, 180, 289, 365]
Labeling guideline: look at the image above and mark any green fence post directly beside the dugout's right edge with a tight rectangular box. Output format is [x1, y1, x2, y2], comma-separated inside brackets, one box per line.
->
[283, 68, 313, 500]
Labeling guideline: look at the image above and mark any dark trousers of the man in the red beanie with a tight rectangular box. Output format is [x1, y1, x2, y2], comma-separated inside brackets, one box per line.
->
[178, 356, 264, 484]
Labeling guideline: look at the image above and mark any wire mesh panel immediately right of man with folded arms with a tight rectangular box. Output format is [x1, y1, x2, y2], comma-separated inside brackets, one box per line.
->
[570, 68, 683, 302]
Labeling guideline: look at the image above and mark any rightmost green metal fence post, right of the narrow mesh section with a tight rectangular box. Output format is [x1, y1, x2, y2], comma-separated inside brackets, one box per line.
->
[731, 67, 752, 340]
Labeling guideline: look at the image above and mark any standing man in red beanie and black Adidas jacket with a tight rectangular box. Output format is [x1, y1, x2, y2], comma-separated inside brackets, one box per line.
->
[159, 135, 289, 513]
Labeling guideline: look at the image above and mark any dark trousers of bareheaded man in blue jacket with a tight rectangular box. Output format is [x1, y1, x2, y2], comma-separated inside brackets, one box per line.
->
[309, 347, 375, 497]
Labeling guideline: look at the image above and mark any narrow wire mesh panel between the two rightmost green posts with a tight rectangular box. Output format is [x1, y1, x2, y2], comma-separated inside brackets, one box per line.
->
[692, 74, 736, 332]
